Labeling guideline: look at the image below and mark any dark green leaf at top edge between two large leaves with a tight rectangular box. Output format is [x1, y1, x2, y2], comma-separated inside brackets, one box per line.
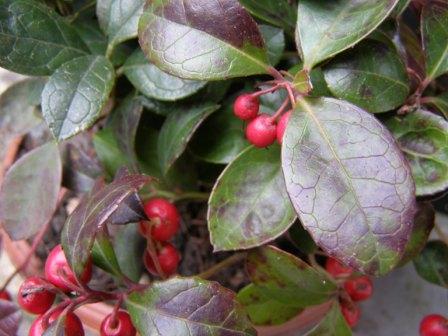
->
[239, 0, 297, 35]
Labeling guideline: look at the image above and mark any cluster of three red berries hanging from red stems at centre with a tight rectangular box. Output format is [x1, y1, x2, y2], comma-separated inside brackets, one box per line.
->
[233, 93, 291, 148]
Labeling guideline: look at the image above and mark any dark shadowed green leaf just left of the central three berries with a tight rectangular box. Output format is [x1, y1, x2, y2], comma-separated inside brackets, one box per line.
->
[192, 100, 249, 164]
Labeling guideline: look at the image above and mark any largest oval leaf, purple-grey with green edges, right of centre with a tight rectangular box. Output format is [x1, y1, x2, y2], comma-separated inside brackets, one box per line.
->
[282, 98, 415, 275]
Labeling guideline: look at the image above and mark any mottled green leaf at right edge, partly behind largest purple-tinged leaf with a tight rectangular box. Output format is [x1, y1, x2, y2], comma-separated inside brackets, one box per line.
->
[386, 110, 448, 196]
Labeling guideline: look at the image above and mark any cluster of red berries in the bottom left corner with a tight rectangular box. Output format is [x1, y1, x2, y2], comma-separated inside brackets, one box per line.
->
[17, 245, 136, 336]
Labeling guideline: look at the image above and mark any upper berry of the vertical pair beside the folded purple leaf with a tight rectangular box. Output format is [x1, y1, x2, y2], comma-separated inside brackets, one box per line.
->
[140, 198, 180, 241]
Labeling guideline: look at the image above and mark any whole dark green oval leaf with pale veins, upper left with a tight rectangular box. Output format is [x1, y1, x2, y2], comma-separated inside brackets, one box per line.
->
[42, 56, 115, 140]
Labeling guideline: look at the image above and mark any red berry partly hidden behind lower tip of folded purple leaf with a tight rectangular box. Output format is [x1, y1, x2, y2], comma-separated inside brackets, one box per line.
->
[45, 245, 92, 292]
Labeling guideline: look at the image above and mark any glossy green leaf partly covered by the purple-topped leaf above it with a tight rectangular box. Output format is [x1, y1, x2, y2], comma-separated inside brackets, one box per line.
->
[123, 49, 207, 101]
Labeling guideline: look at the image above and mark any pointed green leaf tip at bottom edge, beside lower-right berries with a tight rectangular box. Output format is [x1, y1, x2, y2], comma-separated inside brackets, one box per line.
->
[306, 302, 352, 336]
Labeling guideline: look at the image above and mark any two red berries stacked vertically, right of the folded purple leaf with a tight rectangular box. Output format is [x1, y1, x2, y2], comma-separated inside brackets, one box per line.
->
[139, 198, 180, 276]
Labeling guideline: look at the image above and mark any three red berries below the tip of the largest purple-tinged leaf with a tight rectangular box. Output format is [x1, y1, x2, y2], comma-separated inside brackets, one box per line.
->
[325, 257, 373, 328]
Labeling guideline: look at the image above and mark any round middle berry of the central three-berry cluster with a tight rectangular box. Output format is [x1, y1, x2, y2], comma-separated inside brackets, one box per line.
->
[246, 114, 277, 148]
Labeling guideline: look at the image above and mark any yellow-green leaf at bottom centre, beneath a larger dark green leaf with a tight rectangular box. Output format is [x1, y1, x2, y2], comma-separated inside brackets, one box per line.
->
[237, 284, 302, 325]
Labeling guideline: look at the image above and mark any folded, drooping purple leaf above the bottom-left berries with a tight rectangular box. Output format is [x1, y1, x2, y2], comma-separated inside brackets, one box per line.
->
[61, 171, 149, 275]
